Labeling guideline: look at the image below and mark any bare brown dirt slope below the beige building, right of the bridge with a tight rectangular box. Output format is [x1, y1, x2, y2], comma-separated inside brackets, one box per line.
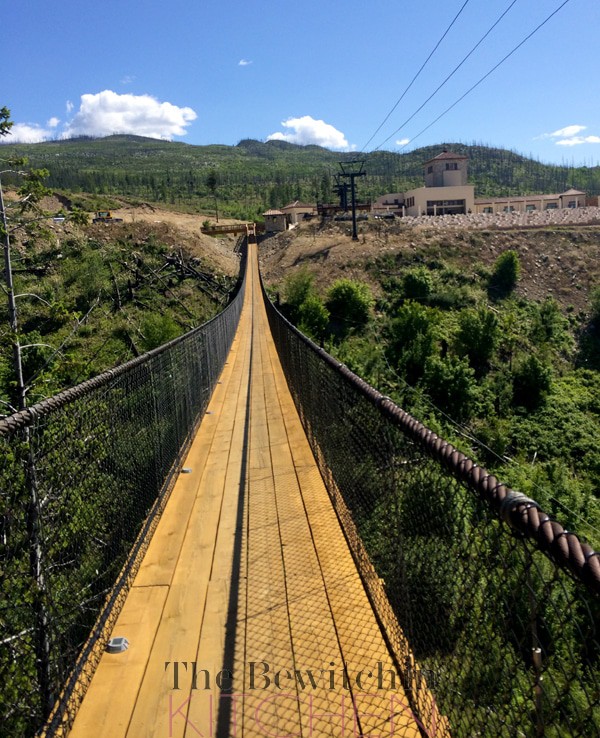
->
[261, 221, 600, 311]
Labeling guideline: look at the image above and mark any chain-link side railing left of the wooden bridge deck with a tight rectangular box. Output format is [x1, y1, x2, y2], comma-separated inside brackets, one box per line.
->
[0, 249, 246, 738]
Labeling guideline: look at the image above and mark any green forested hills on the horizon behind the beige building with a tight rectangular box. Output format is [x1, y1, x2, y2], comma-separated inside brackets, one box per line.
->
[3, 136, 600, 218]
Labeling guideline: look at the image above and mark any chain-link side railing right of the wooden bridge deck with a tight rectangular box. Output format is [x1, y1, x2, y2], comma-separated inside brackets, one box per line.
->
[265, 278, 600, 738]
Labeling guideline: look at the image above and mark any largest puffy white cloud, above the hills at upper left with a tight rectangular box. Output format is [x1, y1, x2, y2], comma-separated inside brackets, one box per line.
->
[62, 90, 197, 140]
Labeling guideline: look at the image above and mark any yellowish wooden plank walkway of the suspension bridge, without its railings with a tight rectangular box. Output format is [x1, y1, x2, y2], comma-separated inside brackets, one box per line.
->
[70, 245, 420, 738]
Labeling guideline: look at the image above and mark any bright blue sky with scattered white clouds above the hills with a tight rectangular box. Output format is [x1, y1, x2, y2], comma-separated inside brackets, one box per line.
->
[0, 0, 600, 165]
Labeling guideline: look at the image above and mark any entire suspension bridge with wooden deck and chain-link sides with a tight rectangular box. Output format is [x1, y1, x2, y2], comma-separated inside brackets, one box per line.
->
[0, 239, 600, 738]
